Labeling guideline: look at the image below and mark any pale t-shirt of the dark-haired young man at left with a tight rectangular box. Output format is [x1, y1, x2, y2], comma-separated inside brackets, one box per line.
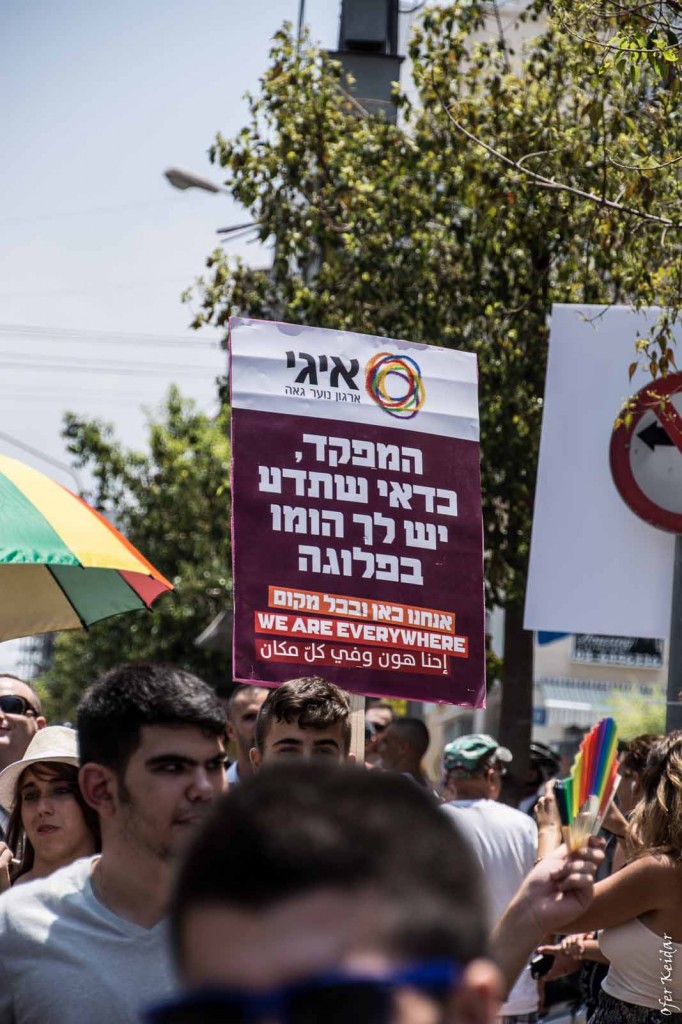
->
[0, 857, 174, 1024]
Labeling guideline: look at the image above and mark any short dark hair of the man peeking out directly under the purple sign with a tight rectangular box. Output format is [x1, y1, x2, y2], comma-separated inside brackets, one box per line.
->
[256, 676, 351, 754]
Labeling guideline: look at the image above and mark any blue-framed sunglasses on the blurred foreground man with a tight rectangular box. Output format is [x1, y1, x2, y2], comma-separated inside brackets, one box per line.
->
[143, 961, 462, 1024]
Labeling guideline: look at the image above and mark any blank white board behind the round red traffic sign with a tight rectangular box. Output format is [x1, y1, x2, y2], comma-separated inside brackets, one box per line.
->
[524, 305, 675, 638]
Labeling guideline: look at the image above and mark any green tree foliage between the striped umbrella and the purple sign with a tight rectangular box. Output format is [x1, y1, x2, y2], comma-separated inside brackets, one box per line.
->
[42, 389, 230, 721]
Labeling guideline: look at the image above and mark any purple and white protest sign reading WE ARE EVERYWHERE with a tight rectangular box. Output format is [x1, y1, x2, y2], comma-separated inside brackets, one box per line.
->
[230, 319, 485, 708]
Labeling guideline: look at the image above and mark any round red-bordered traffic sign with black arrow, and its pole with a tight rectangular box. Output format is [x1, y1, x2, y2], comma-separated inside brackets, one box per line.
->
[609, 374, 682, 732]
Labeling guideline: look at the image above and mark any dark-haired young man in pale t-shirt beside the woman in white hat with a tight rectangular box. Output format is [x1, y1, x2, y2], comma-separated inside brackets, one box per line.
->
[0, 665, 225, 1024]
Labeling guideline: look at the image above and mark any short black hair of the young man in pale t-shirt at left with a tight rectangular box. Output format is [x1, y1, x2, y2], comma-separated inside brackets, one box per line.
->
[77, 662, 225, 779]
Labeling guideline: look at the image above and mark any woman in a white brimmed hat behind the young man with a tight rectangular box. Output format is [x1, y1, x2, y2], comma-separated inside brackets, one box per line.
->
[0, 725, 100, 887]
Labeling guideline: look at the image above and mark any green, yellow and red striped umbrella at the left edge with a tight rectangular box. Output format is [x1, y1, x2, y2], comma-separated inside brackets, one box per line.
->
[0, 456, 173, 640]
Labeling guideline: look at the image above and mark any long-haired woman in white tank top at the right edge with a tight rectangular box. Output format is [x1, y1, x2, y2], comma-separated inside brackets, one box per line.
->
[545, 730, 682, 1024]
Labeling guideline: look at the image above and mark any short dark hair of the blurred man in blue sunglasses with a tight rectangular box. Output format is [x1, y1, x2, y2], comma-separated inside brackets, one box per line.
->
[171, 765, 486, 963]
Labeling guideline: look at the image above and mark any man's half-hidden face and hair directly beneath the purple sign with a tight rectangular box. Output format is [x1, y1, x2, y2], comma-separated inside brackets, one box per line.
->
[251, 677, 352, 768]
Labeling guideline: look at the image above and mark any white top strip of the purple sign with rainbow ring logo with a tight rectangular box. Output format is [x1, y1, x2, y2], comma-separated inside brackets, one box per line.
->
[230, 318, 479, 441]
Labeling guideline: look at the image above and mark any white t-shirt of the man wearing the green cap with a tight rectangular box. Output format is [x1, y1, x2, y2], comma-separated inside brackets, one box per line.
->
[442, 800, 540, 1016]
